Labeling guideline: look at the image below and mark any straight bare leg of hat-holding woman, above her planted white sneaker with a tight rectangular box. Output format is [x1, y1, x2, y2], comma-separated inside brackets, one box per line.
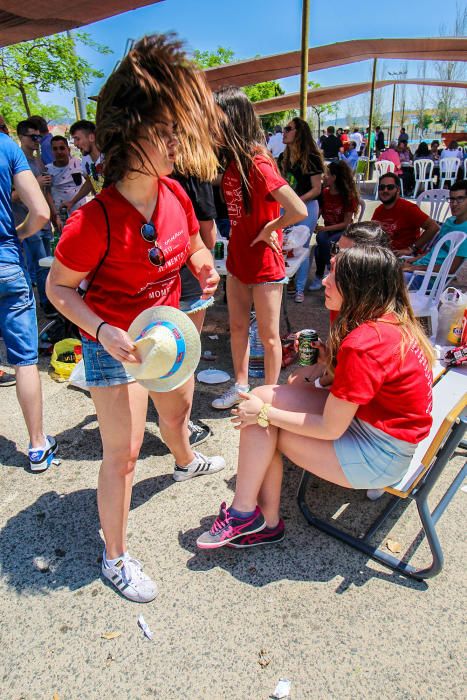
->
[91, 382, 148, 559]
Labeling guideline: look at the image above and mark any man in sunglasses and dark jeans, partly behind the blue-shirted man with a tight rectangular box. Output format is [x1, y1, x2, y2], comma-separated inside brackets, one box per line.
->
[13, 119, 57, 318]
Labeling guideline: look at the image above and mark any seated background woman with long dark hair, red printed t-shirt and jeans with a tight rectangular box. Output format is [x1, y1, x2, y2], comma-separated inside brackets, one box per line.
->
[308, 160, 358, 292]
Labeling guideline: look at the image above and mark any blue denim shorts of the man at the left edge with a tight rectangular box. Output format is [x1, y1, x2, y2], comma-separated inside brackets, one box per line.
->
[0, 263, 38, 367]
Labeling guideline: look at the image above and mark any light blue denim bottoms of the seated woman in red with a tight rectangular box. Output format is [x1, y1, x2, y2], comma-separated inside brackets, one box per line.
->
[334, 418, 416, 489]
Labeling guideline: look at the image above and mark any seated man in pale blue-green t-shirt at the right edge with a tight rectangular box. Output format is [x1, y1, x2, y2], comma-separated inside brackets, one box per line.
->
[403, 180, 467, 289]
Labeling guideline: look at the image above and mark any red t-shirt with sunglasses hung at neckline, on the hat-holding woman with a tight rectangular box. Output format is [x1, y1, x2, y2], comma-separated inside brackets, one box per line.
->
[55, 178, 199, 337]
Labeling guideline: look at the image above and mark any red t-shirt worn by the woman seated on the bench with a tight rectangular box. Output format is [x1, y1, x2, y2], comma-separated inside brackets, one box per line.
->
[331, 321, 433, 444]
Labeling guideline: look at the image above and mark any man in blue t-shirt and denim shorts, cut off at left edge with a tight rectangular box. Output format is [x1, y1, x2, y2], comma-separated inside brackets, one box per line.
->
[0, 133, 57, 472]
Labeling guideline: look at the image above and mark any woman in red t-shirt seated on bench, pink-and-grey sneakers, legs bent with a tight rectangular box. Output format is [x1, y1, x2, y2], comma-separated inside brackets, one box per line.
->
[197, 246, 434, 549]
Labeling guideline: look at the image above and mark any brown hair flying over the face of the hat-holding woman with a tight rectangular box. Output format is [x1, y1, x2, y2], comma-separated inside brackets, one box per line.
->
[96, 34, 220, 182]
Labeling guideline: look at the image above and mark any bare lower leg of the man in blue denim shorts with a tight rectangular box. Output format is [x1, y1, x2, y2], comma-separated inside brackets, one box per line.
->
[15, 365, 44, 447]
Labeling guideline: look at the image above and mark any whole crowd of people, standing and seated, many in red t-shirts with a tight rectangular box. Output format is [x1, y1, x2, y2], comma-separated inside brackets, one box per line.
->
[0, 35, 467, 602]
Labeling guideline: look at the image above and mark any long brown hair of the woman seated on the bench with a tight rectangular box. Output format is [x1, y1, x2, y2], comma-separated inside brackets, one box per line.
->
[329, 245, 434, 372]
